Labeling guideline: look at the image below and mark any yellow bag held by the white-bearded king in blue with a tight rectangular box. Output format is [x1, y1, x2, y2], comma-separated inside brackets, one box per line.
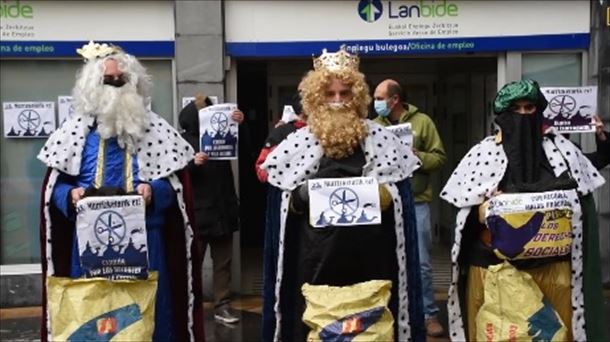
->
[47, 272, 157, 341]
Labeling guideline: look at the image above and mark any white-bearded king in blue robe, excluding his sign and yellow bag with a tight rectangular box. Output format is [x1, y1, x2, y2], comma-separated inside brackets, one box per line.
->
[38, 42, 203, 341]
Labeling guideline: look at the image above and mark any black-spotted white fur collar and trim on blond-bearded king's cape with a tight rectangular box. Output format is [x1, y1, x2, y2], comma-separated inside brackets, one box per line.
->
[261, 120, 423, 341]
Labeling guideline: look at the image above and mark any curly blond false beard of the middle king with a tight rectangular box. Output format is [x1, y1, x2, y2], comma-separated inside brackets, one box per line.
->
[307, 103, 368, 159]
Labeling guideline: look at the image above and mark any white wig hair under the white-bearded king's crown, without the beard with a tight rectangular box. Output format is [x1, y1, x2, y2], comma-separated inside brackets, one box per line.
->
[72, 52, 152, 114]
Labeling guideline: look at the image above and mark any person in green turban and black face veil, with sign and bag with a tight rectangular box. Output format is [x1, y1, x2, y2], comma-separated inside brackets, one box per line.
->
[441, 80, 608, 341]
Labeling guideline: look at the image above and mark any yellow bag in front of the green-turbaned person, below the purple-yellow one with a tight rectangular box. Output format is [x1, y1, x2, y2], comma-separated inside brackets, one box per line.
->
[476, 262, 568, 341]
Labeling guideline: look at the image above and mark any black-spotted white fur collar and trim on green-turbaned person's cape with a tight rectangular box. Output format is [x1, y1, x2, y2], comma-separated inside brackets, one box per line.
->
[440, 130, 604, 341]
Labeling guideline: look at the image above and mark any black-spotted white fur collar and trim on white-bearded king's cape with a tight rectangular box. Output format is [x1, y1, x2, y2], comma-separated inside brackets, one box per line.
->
[38, 112, 202, 340]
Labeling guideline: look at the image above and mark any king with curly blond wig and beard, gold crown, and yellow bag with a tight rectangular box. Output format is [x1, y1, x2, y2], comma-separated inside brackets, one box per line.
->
[261, 49, 425, 341]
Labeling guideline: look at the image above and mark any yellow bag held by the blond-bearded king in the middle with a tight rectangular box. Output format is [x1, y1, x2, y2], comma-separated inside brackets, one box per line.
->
[301, 280, 394, 341]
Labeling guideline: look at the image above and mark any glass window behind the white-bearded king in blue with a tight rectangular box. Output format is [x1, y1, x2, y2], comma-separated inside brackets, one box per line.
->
[0, 60, 173, 265]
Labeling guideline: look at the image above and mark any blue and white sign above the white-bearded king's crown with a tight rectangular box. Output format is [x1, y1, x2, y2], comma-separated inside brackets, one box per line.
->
[0, 0, 176, 58]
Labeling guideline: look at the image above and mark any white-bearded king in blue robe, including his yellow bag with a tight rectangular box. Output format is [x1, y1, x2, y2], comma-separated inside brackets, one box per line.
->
[38, 42, 204, 341]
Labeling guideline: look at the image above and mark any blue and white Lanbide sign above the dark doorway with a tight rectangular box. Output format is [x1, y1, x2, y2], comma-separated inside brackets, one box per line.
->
[225, 0, 591, 57]
